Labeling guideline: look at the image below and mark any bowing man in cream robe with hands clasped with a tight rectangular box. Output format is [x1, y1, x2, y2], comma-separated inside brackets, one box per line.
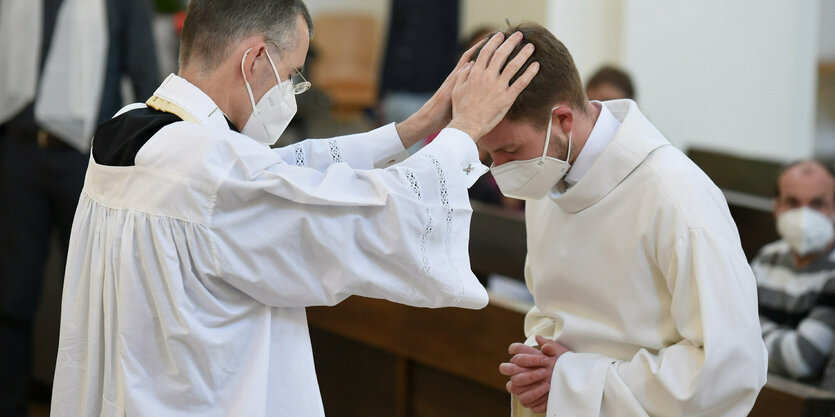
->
[479, 24, 766, 417]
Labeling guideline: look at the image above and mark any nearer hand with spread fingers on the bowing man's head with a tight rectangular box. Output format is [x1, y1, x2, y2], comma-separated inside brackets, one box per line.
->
[449, 32, 539, 141]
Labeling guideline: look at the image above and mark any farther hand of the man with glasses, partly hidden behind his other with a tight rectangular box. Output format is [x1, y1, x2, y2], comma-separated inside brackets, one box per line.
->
[395, 40, 486, 148]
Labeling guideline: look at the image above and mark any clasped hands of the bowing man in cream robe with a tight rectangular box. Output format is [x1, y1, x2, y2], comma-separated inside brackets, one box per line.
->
[499, 336, 569, 413]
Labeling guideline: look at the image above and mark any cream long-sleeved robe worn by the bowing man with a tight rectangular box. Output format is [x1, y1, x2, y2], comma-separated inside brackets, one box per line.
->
[514, 100, 767, 417]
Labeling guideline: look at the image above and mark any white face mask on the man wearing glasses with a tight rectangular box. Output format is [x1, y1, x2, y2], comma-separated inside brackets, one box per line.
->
[241, 49, 296, 146]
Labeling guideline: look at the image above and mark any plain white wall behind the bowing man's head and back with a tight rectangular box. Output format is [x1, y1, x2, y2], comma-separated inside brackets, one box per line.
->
[548, 0, 820, 161]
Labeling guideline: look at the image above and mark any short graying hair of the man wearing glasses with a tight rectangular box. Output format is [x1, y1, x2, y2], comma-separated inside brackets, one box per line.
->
[180, 0, 313, 72]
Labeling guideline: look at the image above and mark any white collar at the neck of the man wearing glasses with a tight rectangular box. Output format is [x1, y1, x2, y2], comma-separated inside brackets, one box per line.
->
[149, 74, 229, 129]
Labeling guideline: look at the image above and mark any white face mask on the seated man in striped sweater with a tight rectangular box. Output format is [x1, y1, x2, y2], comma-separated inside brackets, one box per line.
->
[777, 207, 835, 256]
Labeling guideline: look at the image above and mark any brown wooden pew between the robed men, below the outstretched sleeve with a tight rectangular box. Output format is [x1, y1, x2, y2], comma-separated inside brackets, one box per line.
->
[308, 297, 523, 417]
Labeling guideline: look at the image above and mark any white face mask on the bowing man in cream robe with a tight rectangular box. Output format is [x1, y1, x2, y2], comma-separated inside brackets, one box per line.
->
[490, 106, 571, 200]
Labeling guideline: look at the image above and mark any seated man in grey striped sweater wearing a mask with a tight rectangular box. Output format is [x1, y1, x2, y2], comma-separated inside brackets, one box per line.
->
[751, 161, 835, 385]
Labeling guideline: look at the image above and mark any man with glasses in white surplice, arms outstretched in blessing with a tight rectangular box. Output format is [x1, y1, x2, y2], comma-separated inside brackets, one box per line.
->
[52, 0, 537, 417]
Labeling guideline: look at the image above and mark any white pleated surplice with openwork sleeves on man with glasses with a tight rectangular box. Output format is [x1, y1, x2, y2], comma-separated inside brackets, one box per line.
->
[52, 76, 487, 417]
